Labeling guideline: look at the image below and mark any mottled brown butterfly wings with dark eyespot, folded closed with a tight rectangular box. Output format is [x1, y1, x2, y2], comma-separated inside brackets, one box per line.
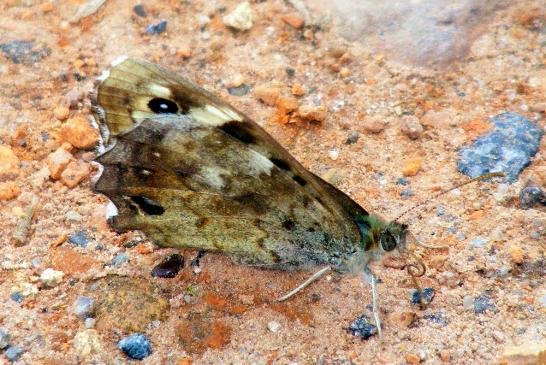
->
[95, 59, 367, 269]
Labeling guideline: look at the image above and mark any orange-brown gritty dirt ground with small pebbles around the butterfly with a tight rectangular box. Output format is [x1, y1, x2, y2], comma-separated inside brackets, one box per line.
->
[0, 0, 546, 365]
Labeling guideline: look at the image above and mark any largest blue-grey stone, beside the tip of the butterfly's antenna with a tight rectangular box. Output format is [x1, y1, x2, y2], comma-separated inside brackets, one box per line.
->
[457, 112, 544, 182]
